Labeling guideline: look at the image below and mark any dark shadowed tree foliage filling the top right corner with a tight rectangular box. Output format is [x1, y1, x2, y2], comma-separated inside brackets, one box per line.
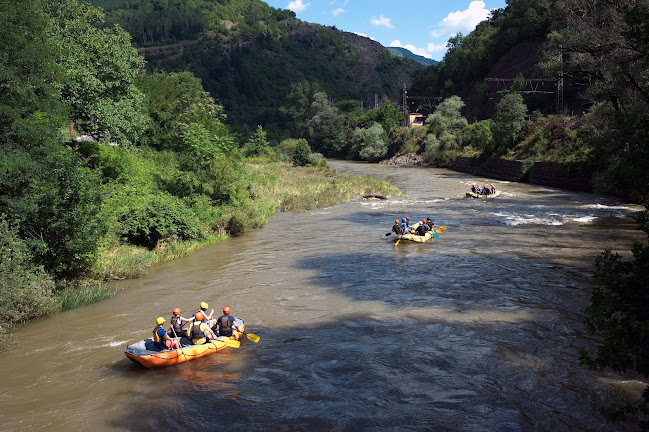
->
[545, 0, 649, 110]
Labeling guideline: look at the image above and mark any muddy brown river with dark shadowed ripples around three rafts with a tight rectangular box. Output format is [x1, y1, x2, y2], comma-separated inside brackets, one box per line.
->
[0, 161, 644, 432]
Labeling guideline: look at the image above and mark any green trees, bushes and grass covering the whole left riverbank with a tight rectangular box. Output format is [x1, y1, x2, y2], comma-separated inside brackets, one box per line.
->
[0, 0, 400, 347]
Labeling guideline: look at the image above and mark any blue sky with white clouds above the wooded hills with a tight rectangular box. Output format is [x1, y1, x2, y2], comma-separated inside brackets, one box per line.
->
[264, 0, 505, 61]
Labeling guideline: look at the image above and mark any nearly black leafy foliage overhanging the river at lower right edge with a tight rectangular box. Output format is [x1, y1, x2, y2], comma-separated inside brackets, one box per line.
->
[581, 205, 649, 429]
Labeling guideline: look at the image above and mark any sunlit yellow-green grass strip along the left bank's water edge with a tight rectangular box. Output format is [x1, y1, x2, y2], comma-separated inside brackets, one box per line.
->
[93, 161, 402, 281]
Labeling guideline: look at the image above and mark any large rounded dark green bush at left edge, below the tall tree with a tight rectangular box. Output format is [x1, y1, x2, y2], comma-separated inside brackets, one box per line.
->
[0, 144, 106, 278]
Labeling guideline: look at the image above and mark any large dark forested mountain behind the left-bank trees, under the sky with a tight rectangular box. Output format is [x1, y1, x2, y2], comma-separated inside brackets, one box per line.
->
[91, 0, 424, 138]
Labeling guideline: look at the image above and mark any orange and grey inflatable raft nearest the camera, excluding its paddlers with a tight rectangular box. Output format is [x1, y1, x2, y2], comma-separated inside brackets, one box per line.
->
[124, 318, 245, 368]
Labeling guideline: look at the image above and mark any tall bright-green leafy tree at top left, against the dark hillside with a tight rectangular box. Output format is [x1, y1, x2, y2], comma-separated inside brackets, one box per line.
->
[43, 0, 149, 145]
